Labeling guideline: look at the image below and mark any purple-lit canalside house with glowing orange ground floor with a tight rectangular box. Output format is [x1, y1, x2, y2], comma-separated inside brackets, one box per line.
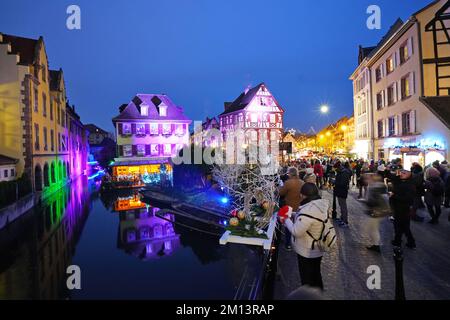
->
[113, 94, 191, 185]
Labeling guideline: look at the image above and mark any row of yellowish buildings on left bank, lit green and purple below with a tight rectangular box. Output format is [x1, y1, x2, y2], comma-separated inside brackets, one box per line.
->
[0, 34, 87, 197]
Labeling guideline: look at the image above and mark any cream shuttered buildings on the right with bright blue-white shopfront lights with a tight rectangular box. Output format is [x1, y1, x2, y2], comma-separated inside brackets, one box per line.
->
[351, 1, 450, 168]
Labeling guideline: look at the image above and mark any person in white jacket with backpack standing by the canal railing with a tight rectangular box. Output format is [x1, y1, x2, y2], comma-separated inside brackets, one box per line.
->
[281, 183, 330, 290]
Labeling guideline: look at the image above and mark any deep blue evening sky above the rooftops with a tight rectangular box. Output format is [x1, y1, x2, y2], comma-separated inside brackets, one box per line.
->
[0, 0, 431, 131]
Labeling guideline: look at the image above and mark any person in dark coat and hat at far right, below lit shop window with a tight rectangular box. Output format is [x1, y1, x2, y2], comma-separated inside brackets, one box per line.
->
[425, 168, 445, 224]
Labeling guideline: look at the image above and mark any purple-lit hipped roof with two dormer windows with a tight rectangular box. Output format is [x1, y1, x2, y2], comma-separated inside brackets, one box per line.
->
[113, 94, 190, 122]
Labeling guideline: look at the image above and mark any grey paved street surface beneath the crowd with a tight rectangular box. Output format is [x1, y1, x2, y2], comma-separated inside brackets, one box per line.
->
[274, 189, 450, 300]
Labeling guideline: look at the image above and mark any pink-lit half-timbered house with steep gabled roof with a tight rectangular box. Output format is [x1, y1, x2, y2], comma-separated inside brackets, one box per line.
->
[219, 83, 284, 150]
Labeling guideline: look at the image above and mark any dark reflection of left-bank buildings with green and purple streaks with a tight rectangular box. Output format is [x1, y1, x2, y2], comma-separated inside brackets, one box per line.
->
[0, 178, 95, 299]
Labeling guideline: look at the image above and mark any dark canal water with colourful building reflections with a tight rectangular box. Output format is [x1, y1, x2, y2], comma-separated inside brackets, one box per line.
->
[0, 178, 264, 299]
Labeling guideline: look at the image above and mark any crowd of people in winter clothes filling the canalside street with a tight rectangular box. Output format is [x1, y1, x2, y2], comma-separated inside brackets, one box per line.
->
[280, 158, 450, 289]
